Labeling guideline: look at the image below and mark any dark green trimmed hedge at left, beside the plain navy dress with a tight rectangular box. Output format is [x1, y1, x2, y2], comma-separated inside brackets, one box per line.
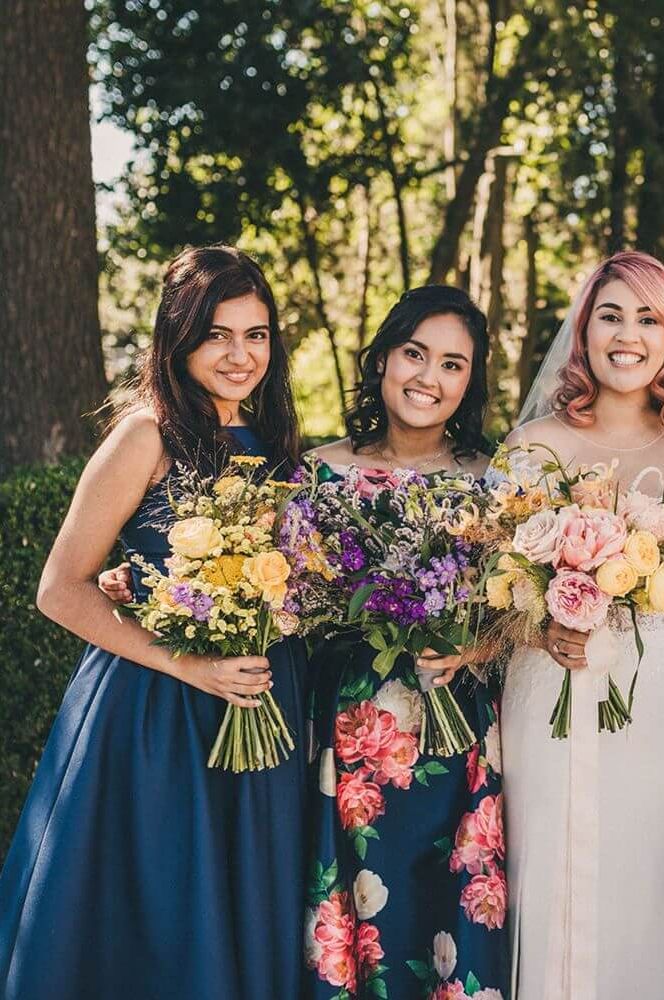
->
[0, 459, 123, 856]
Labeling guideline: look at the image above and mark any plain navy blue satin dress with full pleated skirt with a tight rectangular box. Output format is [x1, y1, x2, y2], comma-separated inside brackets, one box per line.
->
[0, 428, 306, 1000]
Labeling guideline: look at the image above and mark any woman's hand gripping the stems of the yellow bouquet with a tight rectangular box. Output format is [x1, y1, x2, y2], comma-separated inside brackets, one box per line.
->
[171, 655, 273, 708]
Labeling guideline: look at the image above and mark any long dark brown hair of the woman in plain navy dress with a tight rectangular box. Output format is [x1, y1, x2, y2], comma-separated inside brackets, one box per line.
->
[118, 244, 299, 472]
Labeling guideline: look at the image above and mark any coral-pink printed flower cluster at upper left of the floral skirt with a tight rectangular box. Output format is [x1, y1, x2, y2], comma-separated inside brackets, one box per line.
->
[334, 700, 419, 830]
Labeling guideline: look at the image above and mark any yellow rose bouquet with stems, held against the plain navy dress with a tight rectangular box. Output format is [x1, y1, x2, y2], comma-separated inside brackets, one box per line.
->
[127, 455, 299, 773]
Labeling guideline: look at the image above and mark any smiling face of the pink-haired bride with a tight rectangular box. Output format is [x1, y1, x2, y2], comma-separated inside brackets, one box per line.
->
[586, 279, 664, 393]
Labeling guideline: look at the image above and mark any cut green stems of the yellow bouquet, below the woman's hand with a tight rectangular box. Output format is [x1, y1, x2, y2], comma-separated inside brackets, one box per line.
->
[208, 691, 295, 774]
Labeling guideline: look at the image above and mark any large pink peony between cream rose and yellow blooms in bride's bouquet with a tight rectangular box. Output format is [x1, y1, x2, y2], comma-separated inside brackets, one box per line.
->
[554, 504, 627, 573]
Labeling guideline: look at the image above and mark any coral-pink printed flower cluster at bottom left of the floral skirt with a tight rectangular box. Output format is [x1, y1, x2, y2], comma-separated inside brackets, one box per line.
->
[312, 892, 385, 993]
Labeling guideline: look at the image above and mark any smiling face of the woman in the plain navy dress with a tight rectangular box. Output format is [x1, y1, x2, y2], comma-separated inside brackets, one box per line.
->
[187, 292, 270, 420]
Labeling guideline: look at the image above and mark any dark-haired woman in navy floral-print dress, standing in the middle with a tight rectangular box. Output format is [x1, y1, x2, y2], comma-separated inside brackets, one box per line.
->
[305, 286, 507, 1000]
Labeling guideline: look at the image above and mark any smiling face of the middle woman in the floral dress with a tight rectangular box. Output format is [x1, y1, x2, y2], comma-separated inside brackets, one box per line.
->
[381, 313, 473, 428]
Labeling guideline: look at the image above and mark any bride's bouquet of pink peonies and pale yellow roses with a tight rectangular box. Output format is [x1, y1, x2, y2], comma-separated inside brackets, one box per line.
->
[486, 444, 664, 739]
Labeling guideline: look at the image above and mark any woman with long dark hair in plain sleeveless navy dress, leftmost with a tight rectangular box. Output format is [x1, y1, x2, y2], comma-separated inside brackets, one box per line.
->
[0, 246, 305, 1000]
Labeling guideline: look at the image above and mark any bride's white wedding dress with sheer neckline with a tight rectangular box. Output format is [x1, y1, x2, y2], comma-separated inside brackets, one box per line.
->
[501, 428, 664, 1000]
